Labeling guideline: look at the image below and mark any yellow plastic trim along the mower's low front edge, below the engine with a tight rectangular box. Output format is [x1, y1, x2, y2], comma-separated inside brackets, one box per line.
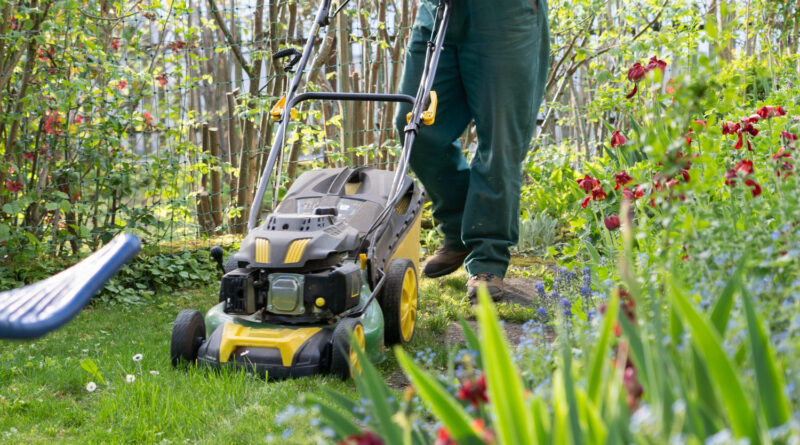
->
[219, 323, 322, 367]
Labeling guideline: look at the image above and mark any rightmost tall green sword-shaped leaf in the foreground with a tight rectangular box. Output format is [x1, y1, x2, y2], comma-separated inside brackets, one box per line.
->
[741, 287, 790, 428]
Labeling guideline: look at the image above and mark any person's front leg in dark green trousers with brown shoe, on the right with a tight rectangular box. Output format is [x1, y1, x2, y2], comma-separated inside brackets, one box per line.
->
[458, 0, 549, 288]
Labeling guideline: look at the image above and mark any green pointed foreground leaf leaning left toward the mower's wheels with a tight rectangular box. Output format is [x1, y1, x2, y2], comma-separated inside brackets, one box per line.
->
[392, 346, 481, 444]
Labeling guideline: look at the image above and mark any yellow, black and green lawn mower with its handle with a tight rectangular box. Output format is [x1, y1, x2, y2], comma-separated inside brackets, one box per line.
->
[170, 0, 451, 378]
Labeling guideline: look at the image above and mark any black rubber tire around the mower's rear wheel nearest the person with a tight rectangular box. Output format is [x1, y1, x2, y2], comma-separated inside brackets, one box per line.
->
[378, 258, 419, 346]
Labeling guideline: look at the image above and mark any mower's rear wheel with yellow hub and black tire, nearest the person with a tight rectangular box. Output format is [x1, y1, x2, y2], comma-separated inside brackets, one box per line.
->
[378, 258, 419, 345]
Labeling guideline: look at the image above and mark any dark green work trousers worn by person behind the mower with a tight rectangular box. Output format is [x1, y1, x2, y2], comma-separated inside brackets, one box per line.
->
[395, 0, 550, 277]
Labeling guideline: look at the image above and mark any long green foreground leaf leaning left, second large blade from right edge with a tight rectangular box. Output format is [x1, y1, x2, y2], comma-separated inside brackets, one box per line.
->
[667, 277, 758, 443]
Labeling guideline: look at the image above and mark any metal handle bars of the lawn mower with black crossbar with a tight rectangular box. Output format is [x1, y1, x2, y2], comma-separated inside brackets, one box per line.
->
[247, 0, 452, 232]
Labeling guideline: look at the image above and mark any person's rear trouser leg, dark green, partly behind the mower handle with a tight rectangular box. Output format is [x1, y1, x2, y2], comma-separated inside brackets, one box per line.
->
[395, 1, 471, 256]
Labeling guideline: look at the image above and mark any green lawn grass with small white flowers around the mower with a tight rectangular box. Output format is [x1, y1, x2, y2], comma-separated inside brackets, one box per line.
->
[0, 271, 544, 443]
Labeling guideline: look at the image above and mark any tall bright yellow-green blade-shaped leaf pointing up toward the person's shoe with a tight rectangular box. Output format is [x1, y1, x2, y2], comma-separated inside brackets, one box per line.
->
[476, 287, 536, 444]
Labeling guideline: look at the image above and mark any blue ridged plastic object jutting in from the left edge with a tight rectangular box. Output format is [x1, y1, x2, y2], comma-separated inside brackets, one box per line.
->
[0, 233, 141, 339]
